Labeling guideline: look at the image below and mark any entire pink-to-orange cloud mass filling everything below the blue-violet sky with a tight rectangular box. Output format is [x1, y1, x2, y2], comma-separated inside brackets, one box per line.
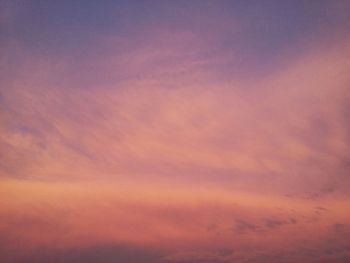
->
[0, 27, 350, 262]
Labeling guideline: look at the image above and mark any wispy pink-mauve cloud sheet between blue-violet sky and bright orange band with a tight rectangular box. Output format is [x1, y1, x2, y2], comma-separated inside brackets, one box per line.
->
[2, 34, 349, 197]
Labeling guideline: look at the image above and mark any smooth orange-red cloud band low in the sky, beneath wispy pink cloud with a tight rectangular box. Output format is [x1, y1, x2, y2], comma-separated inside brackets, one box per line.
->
[0, 180, 349, 262]
